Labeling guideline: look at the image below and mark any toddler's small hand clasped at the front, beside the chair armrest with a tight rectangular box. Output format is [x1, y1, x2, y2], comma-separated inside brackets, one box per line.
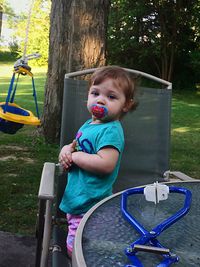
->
[59, 140, 76, 170]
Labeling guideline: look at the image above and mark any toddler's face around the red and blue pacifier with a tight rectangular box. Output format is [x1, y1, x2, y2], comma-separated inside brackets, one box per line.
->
[87, 79, 127, 122]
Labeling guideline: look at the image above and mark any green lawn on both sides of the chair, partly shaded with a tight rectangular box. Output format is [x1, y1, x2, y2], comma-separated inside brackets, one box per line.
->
[0, 63, 200, 237]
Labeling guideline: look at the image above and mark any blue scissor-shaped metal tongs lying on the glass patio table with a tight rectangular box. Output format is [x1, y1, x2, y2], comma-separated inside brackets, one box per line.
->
[121, 186, 192, 267]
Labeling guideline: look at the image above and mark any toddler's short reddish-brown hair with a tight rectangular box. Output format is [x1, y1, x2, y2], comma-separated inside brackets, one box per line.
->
[89, 66, 138, 114]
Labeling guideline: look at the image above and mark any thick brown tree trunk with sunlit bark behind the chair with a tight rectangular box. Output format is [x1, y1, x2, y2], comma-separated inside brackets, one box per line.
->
[42, 0, 110, 143]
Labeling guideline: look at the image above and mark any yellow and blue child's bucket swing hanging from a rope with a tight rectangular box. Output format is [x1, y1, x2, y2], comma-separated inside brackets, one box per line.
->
[0, 53, 40, 134]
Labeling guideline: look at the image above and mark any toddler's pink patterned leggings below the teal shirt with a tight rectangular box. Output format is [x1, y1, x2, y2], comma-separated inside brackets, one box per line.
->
[66, 213, 84, 257]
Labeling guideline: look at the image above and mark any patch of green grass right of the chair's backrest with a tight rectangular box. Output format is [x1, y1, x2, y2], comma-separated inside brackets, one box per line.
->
[170, 91, 200, 179]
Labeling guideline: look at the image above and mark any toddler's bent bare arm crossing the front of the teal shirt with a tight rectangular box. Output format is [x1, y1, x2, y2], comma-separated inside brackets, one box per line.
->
[72, 147, 119, 174]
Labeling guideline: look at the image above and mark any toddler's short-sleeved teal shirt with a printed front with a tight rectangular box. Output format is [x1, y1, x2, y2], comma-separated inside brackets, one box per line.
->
[60, 120, 124, 214]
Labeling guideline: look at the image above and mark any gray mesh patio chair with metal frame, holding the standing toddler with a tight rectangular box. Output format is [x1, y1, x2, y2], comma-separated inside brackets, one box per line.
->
[35, 69, 194, 267]
